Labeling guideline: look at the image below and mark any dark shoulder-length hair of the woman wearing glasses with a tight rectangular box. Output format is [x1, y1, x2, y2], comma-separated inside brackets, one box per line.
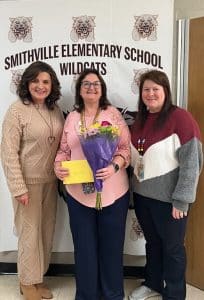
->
[74, 69, 110, 112]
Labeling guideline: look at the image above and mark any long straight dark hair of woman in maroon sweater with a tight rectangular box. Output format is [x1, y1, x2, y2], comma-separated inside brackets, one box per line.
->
[136, 70, 175, 127]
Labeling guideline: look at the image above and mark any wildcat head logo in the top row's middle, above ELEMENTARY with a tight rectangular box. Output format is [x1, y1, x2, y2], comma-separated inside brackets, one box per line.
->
[70, 15, 96, 42]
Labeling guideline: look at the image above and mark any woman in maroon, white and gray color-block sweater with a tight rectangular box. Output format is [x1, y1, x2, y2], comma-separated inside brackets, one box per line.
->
[129, 70, 202, 300]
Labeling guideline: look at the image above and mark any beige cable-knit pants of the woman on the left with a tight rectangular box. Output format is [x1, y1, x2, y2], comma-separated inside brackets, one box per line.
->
[13, 182, 57, 285]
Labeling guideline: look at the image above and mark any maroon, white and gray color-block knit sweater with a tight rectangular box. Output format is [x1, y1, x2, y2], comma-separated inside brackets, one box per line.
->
[131, 107, 203, 211]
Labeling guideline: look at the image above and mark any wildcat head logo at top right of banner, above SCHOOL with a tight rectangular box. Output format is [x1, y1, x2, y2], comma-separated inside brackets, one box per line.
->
[132, 15, 158, 41]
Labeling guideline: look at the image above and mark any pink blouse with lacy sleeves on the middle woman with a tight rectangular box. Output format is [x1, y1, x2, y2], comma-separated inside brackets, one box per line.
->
[55, 106, 130, 207]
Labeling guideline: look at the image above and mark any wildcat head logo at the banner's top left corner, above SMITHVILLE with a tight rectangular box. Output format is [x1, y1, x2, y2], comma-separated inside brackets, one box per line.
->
[8, 17, 32, 43]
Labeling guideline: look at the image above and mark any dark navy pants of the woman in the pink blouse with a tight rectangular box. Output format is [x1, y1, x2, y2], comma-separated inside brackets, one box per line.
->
[67, 193, 129, 300]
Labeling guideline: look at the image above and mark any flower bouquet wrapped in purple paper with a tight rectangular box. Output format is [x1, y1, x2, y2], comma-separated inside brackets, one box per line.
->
[79, 121, 119, 209]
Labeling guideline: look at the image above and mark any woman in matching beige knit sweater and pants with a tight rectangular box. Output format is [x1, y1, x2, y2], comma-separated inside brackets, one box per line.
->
[1, 61, 64, 300]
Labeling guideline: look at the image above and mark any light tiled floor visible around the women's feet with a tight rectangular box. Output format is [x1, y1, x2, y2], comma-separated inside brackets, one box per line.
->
[0, 275, 204, 300]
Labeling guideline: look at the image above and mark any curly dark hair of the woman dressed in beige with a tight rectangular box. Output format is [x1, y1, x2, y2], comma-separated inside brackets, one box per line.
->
[17, 61, 61, 109]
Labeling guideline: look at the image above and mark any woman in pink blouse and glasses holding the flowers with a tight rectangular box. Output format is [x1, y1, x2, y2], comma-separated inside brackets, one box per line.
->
[55, 69, 130, 300]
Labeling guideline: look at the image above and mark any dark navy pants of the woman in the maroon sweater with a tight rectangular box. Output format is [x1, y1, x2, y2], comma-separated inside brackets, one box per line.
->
[134, 194, 187, 300]
